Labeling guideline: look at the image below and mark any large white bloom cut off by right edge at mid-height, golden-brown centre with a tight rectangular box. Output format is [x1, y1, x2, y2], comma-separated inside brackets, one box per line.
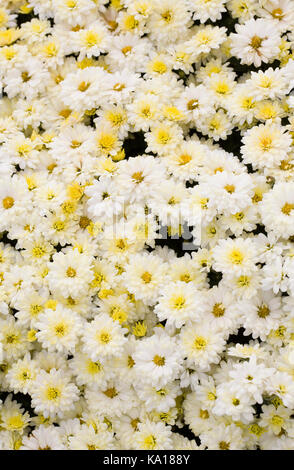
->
[260, 182, 294, 238]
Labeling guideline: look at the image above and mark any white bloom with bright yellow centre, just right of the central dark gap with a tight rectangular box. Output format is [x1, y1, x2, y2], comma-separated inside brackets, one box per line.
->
[213, 238, 259, 276]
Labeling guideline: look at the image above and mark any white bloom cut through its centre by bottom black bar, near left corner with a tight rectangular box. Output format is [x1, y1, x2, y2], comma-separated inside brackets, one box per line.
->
[20, 425, 66, 450]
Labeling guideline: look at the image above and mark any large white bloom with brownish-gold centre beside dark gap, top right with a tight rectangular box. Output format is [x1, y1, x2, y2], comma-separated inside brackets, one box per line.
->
[231, 18, 280, 67]
